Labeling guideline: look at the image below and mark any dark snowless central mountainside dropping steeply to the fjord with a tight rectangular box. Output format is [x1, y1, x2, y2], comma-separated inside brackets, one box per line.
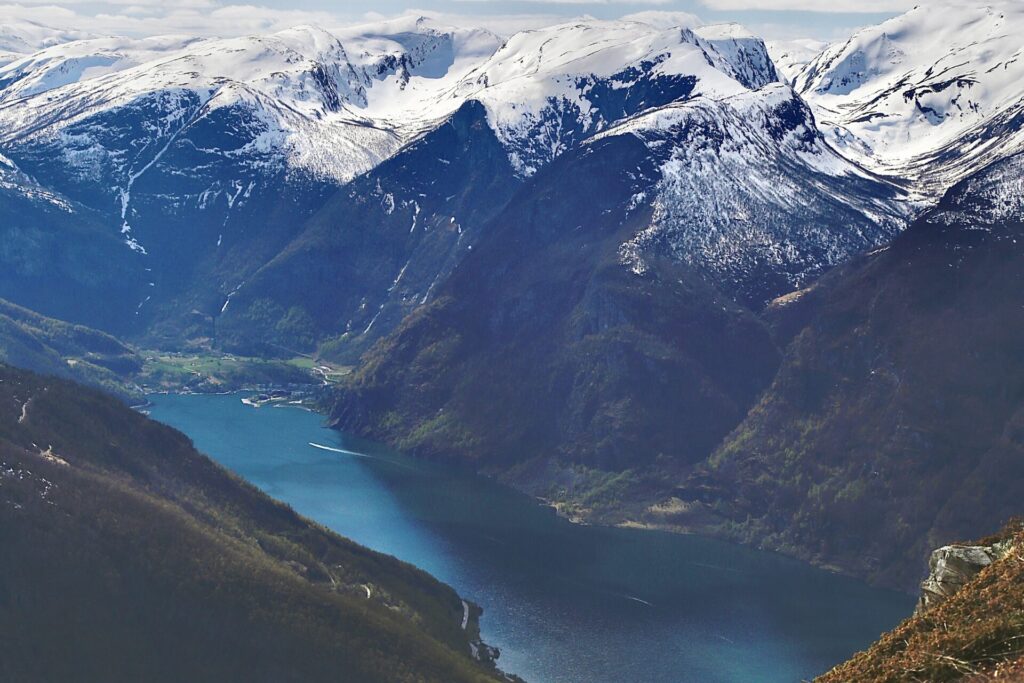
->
[332, 131, 775, 475]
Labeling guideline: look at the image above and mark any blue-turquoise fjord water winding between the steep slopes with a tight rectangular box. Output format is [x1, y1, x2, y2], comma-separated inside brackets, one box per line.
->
[151, 395, 913, 683]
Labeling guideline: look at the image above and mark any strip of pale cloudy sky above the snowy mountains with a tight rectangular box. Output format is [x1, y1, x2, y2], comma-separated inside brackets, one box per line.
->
[0, 0, 926, 40]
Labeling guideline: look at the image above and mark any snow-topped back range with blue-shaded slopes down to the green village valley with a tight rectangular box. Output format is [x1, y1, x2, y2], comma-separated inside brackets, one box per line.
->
[0, 17, 794, 355]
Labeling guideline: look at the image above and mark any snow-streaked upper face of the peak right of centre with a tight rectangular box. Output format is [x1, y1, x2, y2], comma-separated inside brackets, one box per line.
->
[604, 84, 909, 307]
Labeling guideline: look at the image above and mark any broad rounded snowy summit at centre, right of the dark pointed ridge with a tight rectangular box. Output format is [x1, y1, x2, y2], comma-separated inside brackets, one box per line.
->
[458, 22, 777, 175]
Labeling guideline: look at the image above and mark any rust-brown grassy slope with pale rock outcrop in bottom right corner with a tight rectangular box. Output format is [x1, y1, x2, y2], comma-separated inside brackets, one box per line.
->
[818, 521, 1024, 683]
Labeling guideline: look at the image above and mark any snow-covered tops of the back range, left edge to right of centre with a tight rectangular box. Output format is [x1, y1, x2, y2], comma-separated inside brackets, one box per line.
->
[0, 17, 776, 200]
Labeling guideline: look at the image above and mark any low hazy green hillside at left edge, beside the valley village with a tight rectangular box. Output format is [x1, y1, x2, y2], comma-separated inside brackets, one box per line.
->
[0, 299, 142, 402]
